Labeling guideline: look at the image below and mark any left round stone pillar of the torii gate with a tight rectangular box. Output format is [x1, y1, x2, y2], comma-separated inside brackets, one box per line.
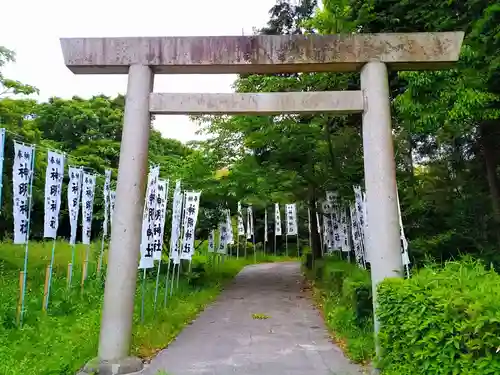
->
[99, 64, 153, 371]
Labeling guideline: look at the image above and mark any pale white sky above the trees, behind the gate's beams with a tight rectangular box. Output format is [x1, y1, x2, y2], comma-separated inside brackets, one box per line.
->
[0, 0, 275, 142]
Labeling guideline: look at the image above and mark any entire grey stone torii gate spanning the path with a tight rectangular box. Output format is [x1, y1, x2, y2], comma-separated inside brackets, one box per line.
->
[61, 32, 464, 375]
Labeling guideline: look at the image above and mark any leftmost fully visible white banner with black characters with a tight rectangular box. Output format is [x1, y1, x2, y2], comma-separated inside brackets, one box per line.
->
[12, 141, 35, 244]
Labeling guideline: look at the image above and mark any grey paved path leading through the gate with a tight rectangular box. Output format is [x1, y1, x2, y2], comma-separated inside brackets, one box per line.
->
[144, 262, 363, 375]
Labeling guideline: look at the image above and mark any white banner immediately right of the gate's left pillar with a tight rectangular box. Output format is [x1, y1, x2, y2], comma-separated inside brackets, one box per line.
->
[139, 167, 160, 269]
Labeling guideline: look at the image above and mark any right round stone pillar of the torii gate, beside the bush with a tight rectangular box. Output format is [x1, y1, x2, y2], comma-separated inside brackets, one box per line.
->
[361, 61, 403, 356]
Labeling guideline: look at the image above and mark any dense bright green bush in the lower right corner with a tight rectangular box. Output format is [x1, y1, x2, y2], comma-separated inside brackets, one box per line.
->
[378, 260, 500, 375]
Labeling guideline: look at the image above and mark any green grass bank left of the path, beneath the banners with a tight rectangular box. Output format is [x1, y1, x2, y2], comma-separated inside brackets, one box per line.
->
[0, 242, 293, 375]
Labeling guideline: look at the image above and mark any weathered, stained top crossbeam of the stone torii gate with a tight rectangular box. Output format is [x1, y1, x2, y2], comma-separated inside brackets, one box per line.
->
[61, 32, 464, 74]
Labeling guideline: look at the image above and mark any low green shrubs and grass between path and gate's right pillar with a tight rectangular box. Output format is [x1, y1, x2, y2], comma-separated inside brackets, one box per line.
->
[308, 256, 374, 362]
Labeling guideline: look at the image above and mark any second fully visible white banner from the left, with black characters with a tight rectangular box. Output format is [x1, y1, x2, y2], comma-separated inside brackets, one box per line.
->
[43, 151, 64, 239]
